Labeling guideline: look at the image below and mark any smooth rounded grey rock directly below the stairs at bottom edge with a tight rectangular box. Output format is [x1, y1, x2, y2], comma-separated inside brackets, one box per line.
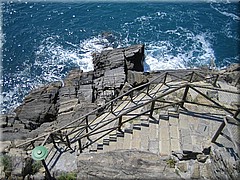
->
[77, 150, 180, 179]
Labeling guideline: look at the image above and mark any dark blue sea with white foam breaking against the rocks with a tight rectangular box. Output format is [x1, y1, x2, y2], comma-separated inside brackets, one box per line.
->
[0, 0, 240, 113]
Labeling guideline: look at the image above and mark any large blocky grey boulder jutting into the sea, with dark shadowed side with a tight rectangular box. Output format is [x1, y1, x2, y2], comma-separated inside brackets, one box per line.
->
[93, 45, 144, 104]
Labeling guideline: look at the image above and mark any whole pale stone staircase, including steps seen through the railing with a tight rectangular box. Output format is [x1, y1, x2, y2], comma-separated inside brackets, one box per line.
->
[64, 79, 229, 156]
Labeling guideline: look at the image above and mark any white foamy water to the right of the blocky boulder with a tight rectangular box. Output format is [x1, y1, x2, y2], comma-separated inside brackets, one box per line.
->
[145, 28, 215, 71]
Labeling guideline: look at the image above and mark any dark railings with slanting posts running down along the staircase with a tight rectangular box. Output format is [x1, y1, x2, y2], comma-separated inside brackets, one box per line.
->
[17, 71, 239, 152]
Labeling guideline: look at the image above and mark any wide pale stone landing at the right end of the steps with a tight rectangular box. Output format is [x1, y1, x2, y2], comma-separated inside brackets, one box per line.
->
[179, 104, 227, 153]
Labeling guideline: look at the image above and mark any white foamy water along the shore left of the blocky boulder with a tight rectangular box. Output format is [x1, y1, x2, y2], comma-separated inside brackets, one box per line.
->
[0, 35, 112, 113]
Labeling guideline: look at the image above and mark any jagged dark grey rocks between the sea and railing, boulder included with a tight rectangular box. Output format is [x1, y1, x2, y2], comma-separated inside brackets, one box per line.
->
[1, 45, 146, 141]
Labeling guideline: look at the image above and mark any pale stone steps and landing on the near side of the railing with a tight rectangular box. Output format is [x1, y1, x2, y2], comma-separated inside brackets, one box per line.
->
[82, 105, 223, 156]
